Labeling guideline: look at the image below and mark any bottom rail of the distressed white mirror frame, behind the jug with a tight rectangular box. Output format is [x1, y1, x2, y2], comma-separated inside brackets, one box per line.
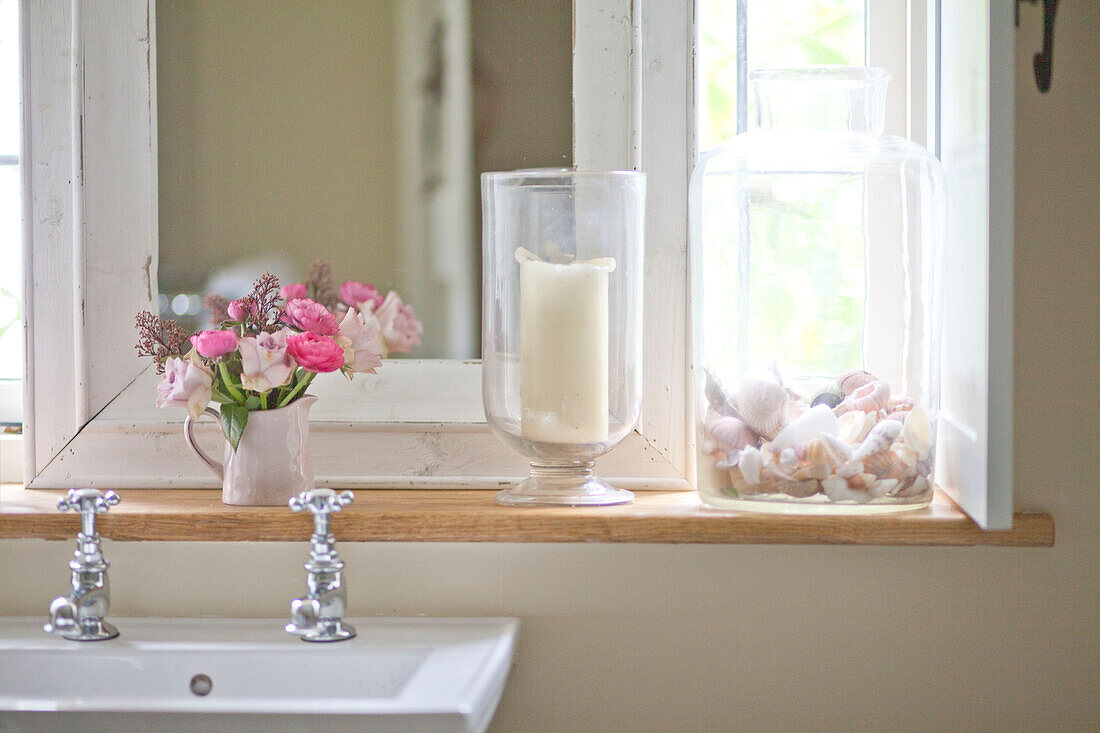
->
[34, 361, 686, 489]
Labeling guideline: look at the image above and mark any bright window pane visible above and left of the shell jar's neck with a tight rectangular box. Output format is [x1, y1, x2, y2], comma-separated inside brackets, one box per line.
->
[699, 0, 867, 151]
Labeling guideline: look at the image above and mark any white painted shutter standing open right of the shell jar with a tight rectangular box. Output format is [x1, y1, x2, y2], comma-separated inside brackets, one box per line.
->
[936, 0, 1014, 528]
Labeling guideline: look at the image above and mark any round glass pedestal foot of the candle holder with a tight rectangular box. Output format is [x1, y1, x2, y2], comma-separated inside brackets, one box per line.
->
[496, 462, 634, 506]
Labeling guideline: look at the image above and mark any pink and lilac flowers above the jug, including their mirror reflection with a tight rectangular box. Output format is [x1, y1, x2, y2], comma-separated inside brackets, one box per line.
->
[136, 263, 424, 450]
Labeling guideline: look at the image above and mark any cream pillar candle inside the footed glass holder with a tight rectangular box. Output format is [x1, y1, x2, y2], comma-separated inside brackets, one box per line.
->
[516, 248, 615, 444]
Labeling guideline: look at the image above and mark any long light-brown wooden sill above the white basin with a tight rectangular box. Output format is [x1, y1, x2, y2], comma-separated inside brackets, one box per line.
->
[0, 484, 1054, 547]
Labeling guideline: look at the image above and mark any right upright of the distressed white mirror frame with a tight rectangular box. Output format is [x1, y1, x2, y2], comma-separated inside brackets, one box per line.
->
[574, 0, 695, 477]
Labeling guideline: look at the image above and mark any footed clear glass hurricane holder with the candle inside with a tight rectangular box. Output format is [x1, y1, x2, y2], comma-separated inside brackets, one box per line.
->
[482, 169, 646, 505]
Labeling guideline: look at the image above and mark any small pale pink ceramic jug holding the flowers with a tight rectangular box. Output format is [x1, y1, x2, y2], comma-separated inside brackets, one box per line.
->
[184, 395, 317, 506]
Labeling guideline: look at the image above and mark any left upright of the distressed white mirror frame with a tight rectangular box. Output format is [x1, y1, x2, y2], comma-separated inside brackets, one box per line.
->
[21, 0, 156, 480]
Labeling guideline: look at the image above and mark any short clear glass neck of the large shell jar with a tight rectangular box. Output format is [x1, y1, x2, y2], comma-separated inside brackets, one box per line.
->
[749, 66, 890, 135]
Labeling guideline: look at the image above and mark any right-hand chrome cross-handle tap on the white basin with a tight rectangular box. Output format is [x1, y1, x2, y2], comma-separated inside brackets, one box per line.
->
[286, 489, 355, 642]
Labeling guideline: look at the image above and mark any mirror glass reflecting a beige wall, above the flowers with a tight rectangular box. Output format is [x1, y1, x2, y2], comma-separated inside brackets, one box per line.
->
[156, 0, 572, 358]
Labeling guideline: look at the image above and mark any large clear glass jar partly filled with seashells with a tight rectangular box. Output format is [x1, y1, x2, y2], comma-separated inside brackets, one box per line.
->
[691, 66, 945, 513]
